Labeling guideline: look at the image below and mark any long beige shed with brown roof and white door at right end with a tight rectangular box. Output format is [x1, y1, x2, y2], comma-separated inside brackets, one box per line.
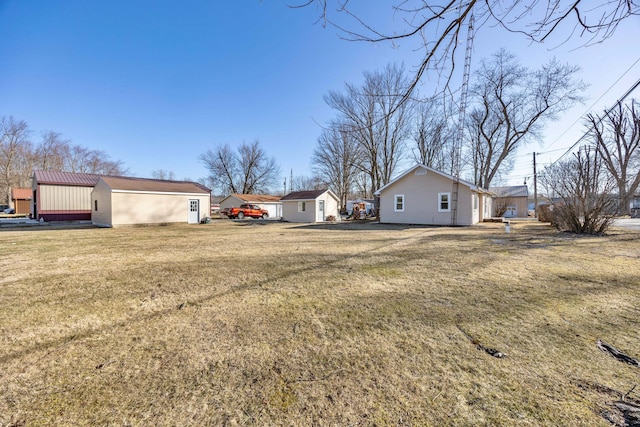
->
[91, 176, 211, 227]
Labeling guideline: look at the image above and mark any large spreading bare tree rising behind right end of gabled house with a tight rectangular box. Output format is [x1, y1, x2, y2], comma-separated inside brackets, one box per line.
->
[468, 49, 585, 188]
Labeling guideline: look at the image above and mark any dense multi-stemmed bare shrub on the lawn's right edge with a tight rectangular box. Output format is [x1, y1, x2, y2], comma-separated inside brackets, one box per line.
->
[540, 147, 616, 234]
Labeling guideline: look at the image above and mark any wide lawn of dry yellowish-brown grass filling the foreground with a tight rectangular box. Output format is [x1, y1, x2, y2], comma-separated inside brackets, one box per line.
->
[0, 221, 640, 427]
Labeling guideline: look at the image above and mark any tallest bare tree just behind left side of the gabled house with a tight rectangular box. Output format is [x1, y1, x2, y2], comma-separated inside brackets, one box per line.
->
[325, 65, 411, 195]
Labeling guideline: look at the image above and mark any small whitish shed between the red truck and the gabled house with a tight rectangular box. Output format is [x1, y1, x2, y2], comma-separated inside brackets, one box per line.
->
[280, 190, 340, 222]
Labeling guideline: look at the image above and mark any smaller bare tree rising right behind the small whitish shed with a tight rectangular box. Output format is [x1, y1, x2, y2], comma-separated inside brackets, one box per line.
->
[311, 123, 361, 209]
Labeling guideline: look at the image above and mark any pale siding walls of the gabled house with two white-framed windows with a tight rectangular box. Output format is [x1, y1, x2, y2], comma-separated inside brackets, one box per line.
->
[380, 169, 483, 225]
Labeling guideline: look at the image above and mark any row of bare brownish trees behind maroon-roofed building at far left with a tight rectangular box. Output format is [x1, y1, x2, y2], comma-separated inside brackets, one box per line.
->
[0, 116, 127, 203]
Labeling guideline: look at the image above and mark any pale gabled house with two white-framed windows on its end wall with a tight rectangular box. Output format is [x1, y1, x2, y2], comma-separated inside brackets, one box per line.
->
[375, 164, 491, 225]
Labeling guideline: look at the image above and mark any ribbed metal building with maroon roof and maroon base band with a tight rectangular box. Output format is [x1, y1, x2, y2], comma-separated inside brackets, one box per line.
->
[31, 171, 100, 221]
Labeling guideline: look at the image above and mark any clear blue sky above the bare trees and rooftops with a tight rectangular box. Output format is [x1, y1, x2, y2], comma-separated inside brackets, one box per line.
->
[0, 0, 640, 189]
